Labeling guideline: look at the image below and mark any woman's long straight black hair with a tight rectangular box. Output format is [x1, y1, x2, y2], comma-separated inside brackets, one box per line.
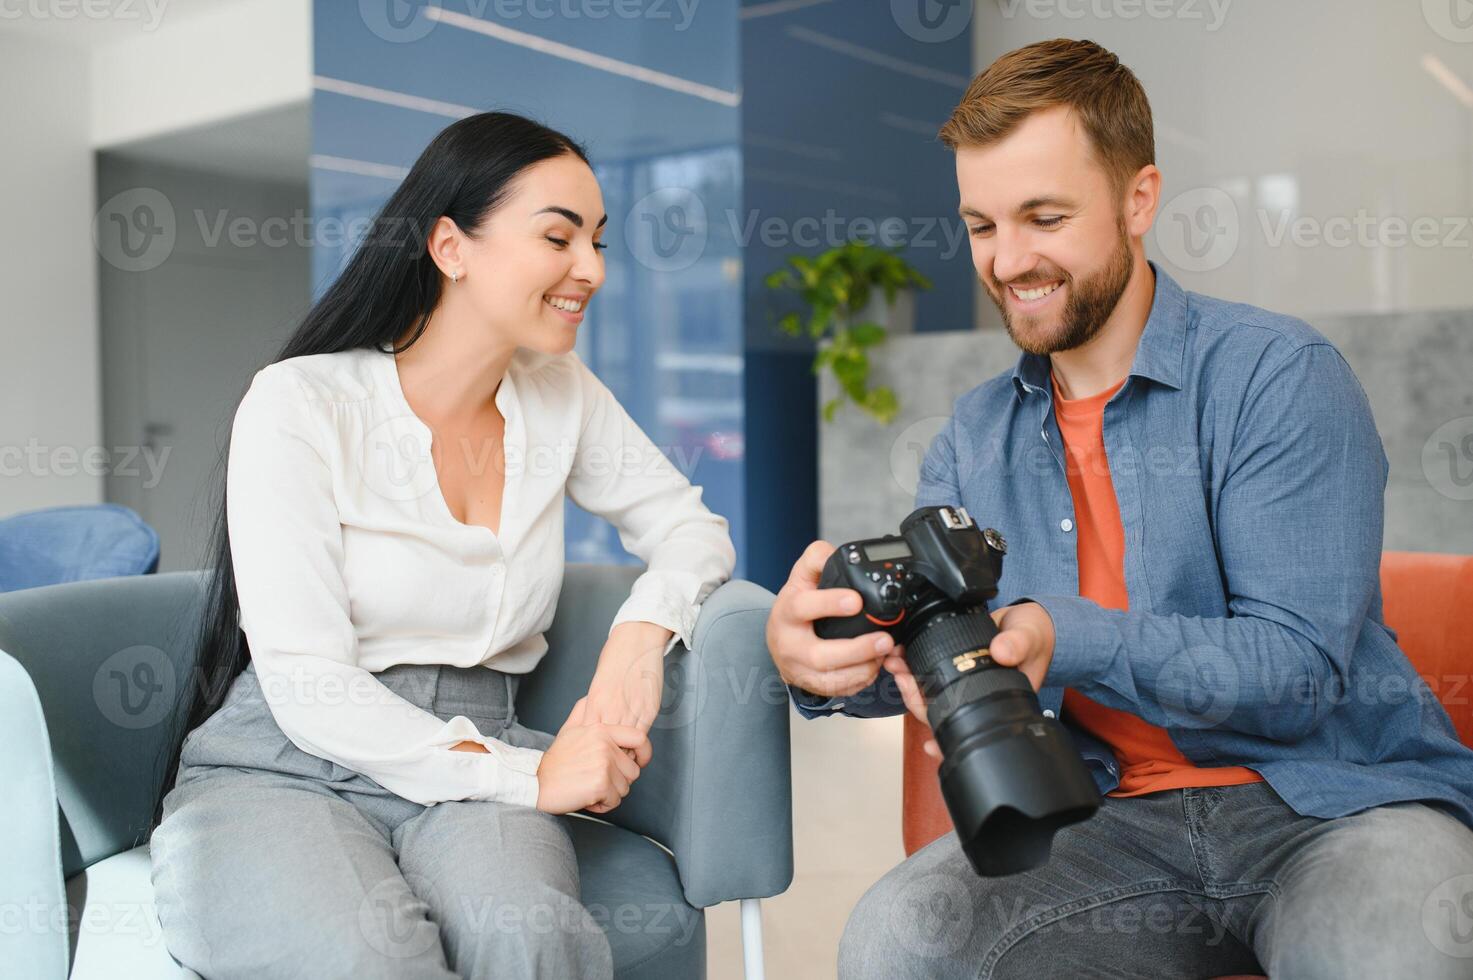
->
[149, 112, 588, 834]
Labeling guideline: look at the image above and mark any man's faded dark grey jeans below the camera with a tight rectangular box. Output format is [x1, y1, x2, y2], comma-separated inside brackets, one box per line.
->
[838, 783, 1473, 980]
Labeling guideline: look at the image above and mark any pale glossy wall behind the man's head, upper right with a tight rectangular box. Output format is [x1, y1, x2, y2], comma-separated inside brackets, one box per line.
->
[974, 0, 1473, 323]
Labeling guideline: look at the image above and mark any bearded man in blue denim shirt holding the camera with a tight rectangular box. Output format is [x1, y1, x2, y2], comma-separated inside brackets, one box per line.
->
[767, 40, 1473, 980]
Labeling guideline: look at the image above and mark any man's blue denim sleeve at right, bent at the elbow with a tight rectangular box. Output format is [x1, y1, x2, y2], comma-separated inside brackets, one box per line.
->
[1015, 343, 1388, 741]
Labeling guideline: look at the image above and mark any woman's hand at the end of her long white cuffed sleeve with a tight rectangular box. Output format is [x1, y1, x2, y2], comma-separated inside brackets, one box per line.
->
[538, 699, 650, 813]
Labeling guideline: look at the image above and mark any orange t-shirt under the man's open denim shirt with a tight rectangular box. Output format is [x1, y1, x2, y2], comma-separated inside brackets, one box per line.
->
[1053, 372, 1262, 796]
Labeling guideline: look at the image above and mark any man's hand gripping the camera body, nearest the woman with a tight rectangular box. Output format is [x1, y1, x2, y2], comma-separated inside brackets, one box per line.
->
[767, 541, 896, 697]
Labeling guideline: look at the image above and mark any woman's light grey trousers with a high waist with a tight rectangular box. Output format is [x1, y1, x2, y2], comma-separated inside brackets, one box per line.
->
[150, 665, 613, 980]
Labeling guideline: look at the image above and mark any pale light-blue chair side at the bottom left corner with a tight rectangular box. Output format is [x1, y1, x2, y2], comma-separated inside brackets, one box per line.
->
[0, 650, 69, 980]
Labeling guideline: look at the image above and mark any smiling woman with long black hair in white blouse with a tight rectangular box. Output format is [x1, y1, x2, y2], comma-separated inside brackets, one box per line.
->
[152, 113, 735, 980]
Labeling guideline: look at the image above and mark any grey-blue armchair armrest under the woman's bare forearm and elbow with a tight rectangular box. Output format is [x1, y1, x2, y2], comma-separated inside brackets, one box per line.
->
[517, 564, 792, 908]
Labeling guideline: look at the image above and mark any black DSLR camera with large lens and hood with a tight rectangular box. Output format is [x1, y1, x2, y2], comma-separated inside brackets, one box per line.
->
[815, 507, 1099, 877]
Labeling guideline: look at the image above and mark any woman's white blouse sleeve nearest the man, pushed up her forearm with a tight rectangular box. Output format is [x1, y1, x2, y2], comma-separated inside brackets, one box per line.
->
[567, 358, 737, 653]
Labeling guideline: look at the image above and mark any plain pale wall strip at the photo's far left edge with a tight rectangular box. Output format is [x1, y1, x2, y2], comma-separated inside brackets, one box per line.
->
[0, 34, 103, 516]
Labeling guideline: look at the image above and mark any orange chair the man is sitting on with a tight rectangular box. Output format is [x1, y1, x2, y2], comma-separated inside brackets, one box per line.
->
[900, 551, 1473, 972]
